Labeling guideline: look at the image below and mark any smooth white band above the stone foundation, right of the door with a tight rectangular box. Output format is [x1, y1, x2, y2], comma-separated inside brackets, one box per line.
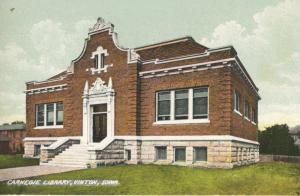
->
[114, 135, 259, 145]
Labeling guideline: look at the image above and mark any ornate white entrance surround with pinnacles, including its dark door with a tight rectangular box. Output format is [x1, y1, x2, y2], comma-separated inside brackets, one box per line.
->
[82, 78, 115, 144]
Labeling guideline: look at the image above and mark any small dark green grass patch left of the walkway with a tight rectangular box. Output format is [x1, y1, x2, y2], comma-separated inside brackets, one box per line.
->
[0, 154, 39, 169]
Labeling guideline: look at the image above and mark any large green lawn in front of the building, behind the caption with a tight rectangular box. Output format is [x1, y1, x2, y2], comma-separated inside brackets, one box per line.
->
[0, 163, 300, 195]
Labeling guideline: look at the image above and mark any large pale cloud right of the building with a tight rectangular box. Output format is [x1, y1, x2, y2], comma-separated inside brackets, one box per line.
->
[201, 0, 300, 129]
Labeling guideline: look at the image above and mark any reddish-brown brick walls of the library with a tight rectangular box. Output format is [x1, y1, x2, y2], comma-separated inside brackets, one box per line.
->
[26, 29, 257, 139]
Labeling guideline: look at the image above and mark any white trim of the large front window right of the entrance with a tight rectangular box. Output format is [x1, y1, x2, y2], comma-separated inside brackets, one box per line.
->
[153, 87, 210, 125]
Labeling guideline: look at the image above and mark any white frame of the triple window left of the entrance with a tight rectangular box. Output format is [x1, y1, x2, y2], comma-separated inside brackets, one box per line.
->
[34, 101, 64, 129]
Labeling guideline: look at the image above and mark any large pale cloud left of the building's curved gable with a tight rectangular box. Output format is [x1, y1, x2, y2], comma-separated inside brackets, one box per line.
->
[0, 19, 94, 124]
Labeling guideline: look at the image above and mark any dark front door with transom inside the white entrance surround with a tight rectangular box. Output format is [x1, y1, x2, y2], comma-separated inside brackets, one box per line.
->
[93, 104, 107, 142]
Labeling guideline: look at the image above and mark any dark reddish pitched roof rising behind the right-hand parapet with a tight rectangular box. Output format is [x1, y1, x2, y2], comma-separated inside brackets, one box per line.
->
[135, 36, 208, 60]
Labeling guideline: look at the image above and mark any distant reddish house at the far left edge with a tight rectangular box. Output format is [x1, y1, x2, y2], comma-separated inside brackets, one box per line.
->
[0, 124, 26, 154]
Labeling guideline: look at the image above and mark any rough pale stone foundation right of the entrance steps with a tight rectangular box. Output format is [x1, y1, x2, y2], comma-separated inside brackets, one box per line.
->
[124, 141, 259, 168]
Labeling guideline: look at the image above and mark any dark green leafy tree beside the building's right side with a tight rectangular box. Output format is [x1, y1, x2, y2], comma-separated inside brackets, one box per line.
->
[258, 124, 300, 155]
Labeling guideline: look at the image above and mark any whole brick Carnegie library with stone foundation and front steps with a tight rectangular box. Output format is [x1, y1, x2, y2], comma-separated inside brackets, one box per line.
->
[24, 18, 260, 168]
